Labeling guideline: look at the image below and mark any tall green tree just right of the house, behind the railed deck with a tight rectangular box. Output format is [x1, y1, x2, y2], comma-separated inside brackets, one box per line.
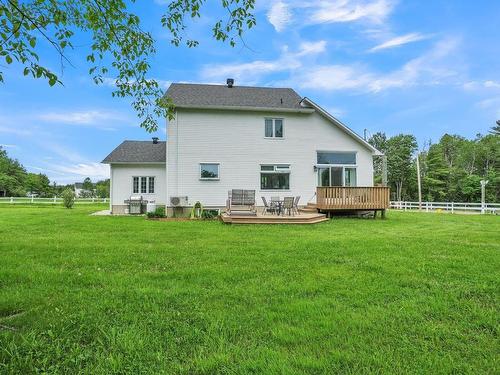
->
[386, 134, 417, 200]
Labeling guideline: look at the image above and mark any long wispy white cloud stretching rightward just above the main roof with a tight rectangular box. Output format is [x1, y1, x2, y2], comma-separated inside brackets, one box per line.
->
[201, 38, 460, 93]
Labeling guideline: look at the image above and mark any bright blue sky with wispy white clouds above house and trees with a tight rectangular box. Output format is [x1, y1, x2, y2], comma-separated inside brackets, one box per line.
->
[0, 0, 500, 183]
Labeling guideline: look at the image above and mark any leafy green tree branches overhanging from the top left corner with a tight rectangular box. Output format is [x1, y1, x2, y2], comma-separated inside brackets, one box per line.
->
[0, 0, 256, 132]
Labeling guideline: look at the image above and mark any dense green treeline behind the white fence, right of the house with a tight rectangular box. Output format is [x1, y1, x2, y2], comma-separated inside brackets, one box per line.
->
[369, 125, 500, 202]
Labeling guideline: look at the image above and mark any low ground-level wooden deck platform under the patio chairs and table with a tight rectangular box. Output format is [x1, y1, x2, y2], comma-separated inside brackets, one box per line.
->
[220, 212, 328, 224]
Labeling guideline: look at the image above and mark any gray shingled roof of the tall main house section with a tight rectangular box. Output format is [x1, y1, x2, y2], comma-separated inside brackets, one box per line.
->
[166, 83, 303, 109]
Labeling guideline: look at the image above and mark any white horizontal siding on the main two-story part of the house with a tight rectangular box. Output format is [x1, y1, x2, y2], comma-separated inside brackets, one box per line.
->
[167, 109, 373, 206]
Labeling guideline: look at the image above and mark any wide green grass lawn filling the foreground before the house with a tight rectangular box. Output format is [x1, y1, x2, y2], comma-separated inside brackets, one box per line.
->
[0, 205, 500, 374]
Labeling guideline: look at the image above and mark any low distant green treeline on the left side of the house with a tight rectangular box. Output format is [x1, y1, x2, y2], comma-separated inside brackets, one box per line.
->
[0, 146, 109, 198]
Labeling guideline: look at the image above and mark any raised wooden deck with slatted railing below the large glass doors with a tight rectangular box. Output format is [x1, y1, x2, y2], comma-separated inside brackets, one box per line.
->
[316, 186, 390, 212]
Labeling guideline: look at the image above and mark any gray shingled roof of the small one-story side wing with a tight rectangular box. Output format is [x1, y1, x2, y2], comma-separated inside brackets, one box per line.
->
[102, 141, 167, 164]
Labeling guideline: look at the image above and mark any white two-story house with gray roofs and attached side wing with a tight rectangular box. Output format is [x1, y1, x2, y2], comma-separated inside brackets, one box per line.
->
[103, 80, 381, 213]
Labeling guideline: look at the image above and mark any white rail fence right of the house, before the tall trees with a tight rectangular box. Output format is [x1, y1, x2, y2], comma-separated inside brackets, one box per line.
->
[391, 201, 500, 215]
